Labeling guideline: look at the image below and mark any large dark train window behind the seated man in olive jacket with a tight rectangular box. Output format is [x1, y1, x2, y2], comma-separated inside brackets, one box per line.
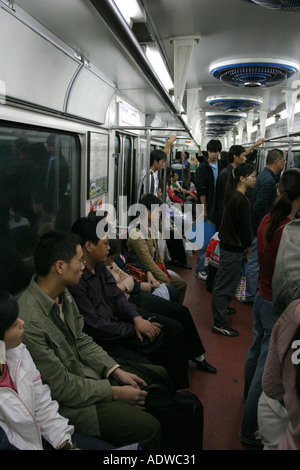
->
[0, 125, 80, 294]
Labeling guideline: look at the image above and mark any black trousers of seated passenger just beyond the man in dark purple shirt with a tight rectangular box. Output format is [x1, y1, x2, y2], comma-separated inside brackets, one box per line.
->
[129, 291, 205, 359]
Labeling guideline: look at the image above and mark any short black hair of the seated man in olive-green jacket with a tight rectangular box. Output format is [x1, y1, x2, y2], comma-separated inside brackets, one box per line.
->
[34, 232, 81, 276]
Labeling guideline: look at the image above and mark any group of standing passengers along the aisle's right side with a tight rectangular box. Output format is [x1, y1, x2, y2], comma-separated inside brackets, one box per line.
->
[138, 134, 300, 449]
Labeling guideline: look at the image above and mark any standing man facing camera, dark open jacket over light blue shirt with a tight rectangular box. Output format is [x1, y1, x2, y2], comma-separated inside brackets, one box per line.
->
[194, 140, 223, 281]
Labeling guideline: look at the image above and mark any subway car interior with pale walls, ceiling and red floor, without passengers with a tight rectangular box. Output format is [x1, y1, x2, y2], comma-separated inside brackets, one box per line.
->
[0, 0, 300, 451]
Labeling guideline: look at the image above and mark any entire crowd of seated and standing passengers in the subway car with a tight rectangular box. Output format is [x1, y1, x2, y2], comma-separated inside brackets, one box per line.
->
[0, 136, 300, 450]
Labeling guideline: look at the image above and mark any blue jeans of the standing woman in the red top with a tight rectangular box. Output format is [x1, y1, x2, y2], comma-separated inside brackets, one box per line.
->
[240, 292, 278, 440]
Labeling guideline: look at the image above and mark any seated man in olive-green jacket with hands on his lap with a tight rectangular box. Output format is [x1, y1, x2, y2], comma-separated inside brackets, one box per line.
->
[19, 232, 168, 450]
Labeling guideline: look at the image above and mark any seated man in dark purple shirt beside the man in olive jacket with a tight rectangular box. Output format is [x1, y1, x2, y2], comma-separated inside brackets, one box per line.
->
[70, 213, 189, 388]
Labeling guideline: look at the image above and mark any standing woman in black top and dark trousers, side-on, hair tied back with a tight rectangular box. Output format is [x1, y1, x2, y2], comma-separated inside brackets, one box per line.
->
[212, 163, 256, 336]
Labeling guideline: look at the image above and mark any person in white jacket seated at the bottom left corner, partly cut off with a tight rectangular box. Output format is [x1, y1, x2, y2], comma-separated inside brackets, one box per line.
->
[0, 291, 113, 450]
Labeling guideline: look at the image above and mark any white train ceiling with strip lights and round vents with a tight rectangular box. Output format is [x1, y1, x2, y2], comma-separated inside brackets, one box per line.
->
[11, 0, 300, 142]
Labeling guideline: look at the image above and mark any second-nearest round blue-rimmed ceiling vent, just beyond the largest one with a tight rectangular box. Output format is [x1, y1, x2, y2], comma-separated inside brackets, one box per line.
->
[206, 96, 263, 113]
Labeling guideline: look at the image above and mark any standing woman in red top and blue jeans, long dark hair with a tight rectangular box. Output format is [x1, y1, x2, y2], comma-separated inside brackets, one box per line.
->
[240, 168, 300, 445]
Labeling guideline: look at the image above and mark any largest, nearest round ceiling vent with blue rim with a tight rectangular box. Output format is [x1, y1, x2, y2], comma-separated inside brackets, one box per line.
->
[210, 59, 298, 88]
